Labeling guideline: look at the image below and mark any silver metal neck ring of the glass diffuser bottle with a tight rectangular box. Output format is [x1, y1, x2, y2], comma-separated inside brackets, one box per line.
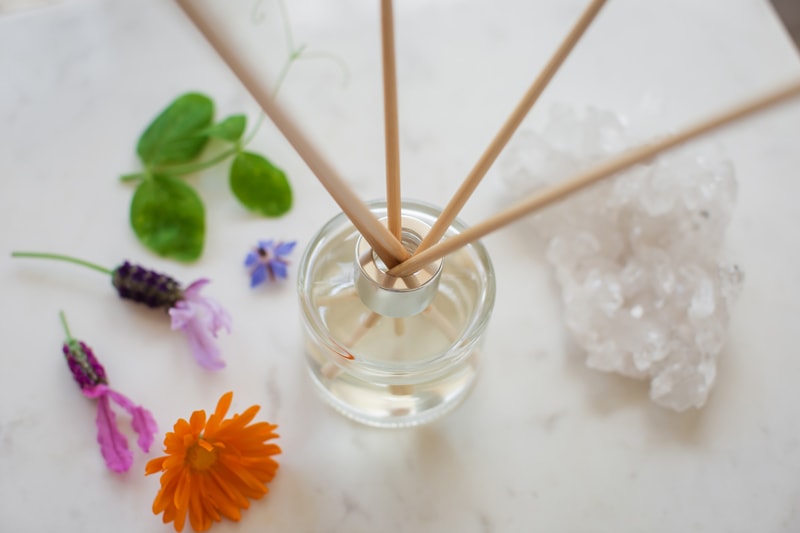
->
[354, 216, 443, 318]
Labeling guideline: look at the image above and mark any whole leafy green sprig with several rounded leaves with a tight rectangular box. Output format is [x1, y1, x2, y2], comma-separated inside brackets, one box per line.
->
[120, 93, 292, 261]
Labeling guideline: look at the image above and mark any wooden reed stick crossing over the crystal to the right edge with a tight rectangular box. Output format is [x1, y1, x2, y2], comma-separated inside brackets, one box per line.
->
[389, 81, 800, 276]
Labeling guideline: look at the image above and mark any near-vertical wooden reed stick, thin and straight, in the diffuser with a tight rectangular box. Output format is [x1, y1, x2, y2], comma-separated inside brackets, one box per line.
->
[381, 0, 403, 240]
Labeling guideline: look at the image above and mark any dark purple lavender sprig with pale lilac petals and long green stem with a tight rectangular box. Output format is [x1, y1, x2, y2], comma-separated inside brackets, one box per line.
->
[11, 252, 231, 370]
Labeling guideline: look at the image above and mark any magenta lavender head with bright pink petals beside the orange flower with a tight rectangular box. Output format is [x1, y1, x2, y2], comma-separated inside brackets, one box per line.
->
[61, 313, 158, 472]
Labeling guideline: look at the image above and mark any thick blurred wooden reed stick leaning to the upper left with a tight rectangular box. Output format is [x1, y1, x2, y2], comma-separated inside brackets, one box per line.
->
[177, 0, 410, 266]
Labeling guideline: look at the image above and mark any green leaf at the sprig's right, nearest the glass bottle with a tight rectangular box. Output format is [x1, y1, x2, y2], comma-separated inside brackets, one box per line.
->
[230, 152, 292, 217]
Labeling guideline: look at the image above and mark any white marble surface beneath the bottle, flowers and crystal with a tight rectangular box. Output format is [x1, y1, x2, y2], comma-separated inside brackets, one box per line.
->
[0, 0, 800, 533]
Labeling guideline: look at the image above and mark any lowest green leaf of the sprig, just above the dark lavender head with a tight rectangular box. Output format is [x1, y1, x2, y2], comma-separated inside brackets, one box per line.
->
[130, 176, 205, 261]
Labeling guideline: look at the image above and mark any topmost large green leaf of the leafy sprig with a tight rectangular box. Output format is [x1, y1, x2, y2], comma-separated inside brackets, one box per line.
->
[136, 93, 214, 167]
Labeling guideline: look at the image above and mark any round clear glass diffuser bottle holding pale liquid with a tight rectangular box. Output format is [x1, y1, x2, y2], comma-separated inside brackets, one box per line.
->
[298, 201, 495, 427]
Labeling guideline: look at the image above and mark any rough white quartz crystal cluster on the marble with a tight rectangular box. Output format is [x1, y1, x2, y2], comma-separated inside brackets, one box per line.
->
[498, 106, 743, 411]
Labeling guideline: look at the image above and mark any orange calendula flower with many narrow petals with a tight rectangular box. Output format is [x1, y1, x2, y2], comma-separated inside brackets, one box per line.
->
[145, 392, 281, 531]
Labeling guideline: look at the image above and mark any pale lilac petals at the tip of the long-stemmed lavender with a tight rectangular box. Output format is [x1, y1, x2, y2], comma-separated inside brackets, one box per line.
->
[169, 279, 231, 370]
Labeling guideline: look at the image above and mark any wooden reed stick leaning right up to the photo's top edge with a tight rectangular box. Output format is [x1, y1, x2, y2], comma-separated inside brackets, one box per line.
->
[415, 0, 606, 254]
